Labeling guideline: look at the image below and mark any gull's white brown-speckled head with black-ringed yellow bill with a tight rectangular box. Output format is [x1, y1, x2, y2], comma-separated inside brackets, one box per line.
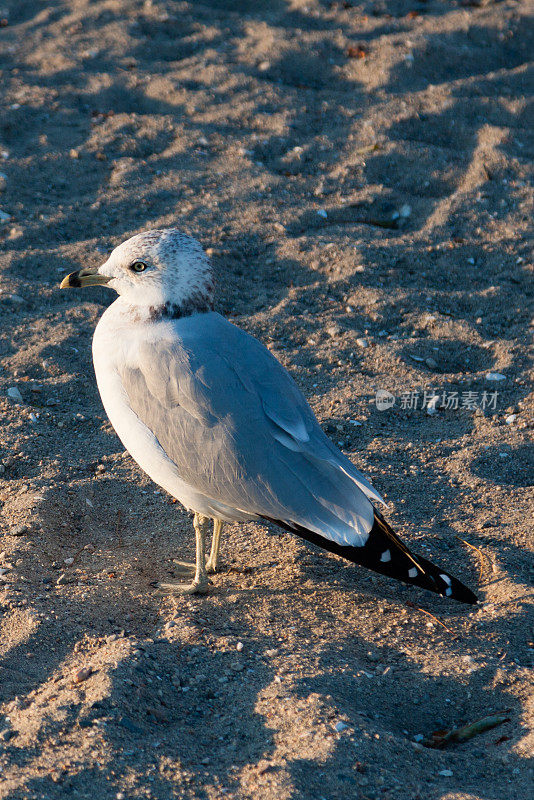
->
[61, 228, 213, 316]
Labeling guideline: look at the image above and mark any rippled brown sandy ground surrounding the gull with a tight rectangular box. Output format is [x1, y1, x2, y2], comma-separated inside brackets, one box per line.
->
[0, 0, 534, 800]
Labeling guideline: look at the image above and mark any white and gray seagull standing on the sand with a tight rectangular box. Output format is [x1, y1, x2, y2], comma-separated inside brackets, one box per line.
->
[61, 228, 477, 603]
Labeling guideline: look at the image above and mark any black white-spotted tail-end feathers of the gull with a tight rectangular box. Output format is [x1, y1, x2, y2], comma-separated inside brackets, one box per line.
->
[270, 509, 478, 604]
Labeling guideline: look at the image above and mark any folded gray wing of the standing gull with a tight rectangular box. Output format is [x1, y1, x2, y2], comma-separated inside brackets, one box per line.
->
[120, 313, 383, 545]
